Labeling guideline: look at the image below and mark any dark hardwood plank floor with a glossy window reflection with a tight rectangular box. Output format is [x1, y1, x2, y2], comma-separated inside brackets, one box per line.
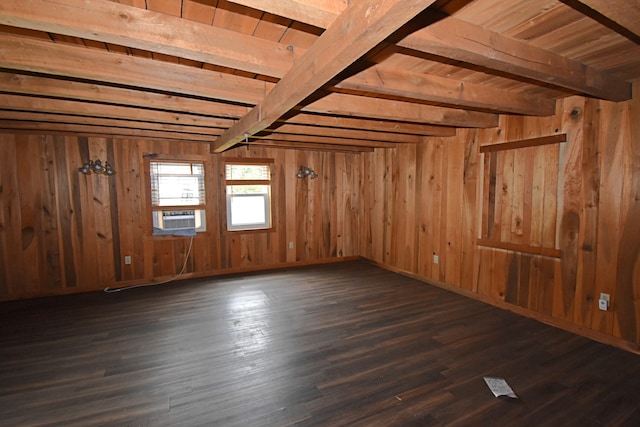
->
[0, 262, 640, 427]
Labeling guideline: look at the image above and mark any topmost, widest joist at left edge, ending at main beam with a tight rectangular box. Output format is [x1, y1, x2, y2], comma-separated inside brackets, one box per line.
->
[0, 0, 294, 77]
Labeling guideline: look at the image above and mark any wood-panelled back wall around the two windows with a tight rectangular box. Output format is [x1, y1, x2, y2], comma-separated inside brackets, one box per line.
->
[0, 137, 362, 300]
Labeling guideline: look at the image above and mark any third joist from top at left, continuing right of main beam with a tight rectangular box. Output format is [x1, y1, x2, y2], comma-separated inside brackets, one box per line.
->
[0, 72, 455, 136]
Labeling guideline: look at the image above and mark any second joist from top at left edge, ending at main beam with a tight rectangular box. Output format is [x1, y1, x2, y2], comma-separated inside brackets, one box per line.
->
[0, 36, 273, 105]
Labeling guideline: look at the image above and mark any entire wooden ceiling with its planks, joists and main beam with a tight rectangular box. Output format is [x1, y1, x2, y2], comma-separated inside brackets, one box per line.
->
[0, 0, 640, 152]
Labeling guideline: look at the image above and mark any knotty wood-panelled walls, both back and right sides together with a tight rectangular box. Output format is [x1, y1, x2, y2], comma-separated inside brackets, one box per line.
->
[0, 84, 640, 348]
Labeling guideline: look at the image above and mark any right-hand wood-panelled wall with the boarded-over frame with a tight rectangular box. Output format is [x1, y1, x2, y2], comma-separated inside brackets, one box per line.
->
[360, 88, 640, 349]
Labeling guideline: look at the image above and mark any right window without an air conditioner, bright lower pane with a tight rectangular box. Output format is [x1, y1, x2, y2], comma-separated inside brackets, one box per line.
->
[225, 162, 271, 231]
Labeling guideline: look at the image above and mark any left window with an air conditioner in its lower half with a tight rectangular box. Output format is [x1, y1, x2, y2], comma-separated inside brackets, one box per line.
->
[149, 161, 206, 235]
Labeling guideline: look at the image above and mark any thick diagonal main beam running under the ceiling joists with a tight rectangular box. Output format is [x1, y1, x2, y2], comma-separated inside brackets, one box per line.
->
[214, 0, 435, 152]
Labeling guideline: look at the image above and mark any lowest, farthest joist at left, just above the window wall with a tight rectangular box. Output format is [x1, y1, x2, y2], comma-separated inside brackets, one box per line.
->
[0, 120, 212, 143]
